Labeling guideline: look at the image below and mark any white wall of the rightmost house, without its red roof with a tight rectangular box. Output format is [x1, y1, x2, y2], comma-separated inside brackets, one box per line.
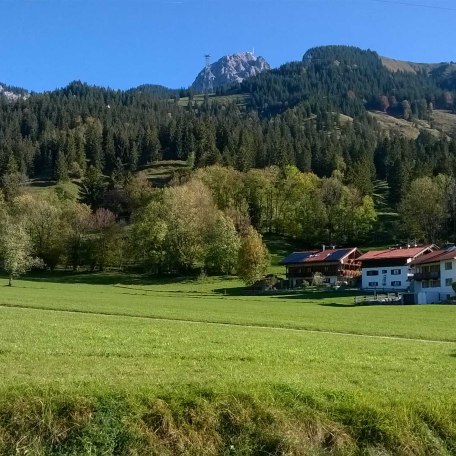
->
[413, 259, 456, 304]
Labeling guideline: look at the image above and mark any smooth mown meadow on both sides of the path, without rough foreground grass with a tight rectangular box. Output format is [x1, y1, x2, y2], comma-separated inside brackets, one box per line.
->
[0, 285, 456, 399]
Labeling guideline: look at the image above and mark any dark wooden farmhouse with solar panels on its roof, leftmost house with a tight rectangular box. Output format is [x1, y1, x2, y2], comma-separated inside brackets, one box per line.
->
[280, 246, 361, 288]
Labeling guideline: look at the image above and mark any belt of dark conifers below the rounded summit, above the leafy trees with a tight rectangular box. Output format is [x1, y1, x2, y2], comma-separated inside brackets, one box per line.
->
[0, 83, 456, 205]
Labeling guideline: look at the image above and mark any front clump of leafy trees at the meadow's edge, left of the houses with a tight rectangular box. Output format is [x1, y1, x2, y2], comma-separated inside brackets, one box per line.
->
[0, 171, 269, 284]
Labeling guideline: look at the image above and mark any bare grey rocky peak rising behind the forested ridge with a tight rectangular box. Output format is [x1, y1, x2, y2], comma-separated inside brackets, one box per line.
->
[191, 52, 271, 92]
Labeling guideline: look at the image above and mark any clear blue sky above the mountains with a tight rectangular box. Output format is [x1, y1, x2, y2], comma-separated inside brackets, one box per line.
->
[0, 0, 456, 91]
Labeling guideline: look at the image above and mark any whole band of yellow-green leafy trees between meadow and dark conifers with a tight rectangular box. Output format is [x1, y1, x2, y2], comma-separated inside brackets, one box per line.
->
[0, 165, 456, 283]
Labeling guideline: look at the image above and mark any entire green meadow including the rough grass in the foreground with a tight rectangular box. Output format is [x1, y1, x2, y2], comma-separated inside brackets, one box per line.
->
[0, 273, 456, 454]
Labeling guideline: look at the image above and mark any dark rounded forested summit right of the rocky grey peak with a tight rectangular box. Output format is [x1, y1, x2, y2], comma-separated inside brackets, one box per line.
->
[239, 46, 456, 116]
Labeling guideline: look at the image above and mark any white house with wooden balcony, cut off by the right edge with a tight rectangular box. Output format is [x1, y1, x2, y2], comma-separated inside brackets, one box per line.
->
[411, 247, 456, 304]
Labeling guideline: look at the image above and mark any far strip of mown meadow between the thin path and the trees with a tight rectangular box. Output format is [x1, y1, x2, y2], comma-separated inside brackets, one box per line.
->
[0, 274, 456, 342]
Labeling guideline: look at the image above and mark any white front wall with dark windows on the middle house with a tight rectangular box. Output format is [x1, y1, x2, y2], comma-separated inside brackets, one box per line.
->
[361, 260, 412, 291]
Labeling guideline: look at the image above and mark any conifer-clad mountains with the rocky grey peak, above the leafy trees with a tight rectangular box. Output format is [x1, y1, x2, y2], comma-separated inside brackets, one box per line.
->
[0, 46, 456, 201]
